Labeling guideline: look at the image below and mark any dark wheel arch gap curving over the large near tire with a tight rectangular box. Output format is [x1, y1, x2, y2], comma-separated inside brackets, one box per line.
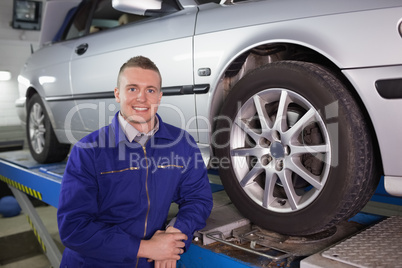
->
[209, 42, 384, 174]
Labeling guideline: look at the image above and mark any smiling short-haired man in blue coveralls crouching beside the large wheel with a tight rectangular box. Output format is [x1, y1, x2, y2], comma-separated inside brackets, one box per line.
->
[57, 56, 212, 268]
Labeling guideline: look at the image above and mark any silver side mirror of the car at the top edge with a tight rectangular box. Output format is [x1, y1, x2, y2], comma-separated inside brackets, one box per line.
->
[112, 0, 179, 16]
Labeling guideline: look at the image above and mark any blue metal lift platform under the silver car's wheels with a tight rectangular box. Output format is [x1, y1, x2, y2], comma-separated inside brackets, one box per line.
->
[0, 151, 402, 268]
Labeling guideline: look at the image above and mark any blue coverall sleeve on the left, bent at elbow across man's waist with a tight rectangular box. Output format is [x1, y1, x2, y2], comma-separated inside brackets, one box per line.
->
[57, 146, 140, 262]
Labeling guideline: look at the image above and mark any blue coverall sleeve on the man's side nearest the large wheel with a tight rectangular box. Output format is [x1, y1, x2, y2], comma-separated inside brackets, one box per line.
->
[174, 139, 213, 249]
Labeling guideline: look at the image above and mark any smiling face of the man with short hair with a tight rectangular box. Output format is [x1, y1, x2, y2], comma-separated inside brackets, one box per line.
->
[114, 67, 162, 132]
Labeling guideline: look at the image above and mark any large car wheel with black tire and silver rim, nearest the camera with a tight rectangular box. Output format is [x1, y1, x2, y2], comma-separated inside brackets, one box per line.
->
[213, 61, 380, 235]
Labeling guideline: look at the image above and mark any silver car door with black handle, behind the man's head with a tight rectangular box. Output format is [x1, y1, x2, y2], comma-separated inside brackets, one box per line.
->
[70, 1, 197, 140]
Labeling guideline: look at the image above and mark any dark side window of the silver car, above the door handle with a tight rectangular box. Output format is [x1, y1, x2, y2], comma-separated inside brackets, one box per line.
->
[64, 0, 146, 40]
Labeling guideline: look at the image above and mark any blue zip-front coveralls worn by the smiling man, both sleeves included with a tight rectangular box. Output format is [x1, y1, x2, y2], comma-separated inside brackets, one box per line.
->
[57, 114, 212, 268]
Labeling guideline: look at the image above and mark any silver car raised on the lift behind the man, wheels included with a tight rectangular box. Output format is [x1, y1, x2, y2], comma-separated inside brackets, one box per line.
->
[17, 0, 402, 235]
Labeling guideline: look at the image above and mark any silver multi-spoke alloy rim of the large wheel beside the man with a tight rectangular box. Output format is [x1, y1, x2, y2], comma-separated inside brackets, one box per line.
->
[230, 89, 331, 213]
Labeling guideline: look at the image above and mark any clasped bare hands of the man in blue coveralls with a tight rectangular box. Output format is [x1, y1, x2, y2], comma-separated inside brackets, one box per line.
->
[137, 227, 187, 262]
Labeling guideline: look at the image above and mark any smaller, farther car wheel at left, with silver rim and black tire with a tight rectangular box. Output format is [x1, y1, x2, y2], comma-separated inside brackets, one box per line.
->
[26, 94, 71, 163]
